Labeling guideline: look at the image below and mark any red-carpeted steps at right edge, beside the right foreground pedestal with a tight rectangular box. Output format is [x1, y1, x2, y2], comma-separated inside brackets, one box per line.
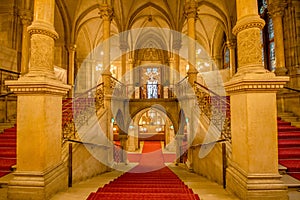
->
[277, 118, 300, 180]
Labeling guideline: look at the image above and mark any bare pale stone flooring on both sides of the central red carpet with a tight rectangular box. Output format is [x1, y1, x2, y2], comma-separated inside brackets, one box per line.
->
[0, 163, 300, 200]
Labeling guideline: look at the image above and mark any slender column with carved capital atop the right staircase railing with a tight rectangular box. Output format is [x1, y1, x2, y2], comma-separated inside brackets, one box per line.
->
[185, 0, 198, 85]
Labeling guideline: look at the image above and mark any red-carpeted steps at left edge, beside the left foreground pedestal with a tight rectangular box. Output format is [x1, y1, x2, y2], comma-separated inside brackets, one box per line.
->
[0, 127, 17, 177]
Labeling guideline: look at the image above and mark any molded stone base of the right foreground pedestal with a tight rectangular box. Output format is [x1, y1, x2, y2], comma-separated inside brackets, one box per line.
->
[226, 166, 289, 200]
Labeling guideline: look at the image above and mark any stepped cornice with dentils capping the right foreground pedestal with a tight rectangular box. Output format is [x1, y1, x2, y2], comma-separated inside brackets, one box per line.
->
[225, 73, 289, 94]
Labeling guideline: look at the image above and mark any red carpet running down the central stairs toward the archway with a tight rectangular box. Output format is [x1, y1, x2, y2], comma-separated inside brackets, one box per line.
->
[87, 141, 200, 200]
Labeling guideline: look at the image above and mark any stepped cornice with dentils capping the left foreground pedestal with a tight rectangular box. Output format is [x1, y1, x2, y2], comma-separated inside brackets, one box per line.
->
[5, 80, 71, 96]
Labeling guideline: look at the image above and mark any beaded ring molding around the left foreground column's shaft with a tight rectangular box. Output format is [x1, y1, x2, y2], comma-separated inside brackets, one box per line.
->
[27, 21, 58, 40]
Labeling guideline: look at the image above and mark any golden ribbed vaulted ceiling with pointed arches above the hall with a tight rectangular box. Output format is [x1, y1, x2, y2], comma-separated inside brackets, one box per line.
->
[55, 0, 236, 60]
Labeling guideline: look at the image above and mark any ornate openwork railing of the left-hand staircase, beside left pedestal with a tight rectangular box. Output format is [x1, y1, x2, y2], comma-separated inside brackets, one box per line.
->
[62, 83, 104, 141]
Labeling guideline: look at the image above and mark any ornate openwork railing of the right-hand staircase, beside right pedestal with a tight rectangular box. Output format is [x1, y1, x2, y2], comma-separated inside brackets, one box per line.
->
[194, 82, 231, 141]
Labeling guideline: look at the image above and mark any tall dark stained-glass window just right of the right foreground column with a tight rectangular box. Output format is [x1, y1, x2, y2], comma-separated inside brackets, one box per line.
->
[258, 0, 276, 71]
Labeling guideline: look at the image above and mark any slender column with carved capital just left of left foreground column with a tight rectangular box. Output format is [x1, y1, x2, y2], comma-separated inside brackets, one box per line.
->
[19, 9, 32, 75]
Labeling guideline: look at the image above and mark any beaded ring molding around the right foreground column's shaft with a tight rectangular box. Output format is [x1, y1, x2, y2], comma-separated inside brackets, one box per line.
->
[232, 15, 265, 35]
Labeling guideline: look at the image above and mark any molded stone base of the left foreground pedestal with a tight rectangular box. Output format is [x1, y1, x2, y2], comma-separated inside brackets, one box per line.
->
[7, 163, 68, 200]
